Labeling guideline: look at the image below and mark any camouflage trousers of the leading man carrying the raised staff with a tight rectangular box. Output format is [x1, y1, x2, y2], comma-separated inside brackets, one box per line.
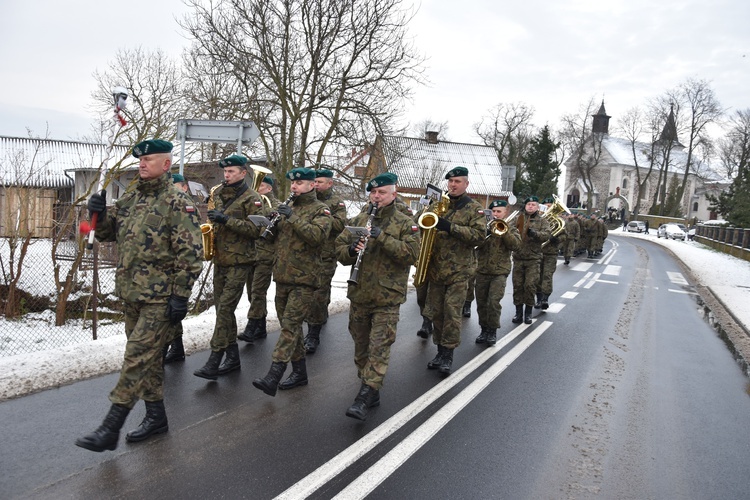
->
[109, 302, 170, 409]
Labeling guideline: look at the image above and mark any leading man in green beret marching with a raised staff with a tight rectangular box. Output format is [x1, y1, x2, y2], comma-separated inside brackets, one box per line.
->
[75, 139, 203, 452]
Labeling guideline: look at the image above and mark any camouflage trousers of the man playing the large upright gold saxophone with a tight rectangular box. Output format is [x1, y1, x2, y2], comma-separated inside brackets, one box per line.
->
[427, 280, 469, 349]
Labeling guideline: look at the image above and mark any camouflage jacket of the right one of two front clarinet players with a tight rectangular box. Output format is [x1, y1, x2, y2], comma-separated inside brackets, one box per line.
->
[336, 203, 419, 307]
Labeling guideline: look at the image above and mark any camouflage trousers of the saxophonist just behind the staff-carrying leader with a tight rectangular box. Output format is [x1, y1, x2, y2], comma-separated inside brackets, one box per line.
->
[211, 265, 251, 352]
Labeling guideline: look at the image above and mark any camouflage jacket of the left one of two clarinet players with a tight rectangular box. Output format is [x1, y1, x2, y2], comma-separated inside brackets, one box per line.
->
[273, 189, 333, 288]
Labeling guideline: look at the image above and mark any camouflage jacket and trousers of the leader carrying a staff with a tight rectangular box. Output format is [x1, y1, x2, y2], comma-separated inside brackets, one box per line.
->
[96, 174, 203, 408]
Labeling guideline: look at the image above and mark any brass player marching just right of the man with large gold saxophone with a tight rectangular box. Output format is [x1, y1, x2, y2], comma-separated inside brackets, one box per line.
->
[475, 200, 521, 346]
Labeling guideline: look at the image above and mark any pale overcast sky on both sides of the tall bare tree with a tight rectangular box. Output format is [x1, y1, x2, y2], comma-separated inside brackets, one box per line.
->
[0, 0, 750, 142]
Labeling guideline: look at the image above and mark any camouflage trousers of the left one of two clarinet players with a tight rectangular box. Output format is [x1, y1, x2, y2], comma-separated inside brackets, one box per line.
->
[271, 283, 315, 363]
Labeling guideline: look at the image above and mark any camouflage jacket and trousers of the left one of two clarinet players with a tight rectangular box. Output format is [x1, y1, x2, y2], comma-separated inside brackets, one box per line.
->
[272, 189, 333, 363]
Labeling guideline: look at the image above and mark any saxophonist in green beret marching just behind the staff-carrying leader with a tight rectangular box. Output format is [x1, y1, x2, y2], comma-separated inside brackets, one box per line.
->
[193, 155, 264, 380]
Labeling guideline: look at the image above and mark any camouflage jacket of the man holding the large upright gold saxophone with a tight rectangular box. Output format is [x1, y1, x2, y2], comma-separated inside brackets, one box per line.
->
[427, 195, 487, 285]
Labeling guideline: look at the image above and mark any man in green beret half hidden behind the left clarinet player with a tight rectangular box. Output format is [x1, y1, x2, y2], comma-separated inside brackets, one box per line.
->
[305, 168, 347, 354]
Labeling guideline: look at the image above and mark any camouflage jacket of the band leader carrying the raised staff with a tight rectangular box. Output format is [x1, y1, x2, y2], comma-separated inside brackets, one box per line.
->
[96, 174, 203, 303]
